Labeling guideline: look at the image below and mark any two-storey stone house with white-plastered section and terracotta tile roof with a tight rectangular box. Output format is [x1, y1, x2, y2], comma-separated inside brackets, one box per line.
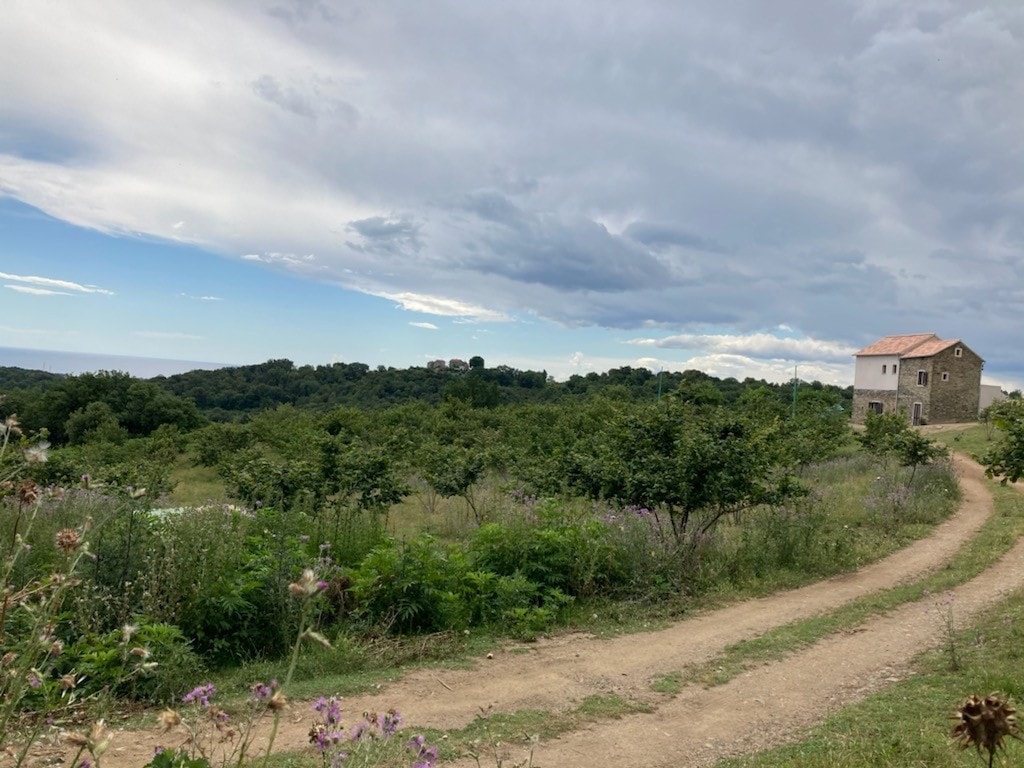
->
[852, 334, 985, 425]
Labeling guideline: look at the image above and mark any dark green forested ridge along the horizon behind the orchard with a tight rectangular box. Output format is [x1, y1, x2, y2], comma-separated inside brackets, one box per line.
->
[0, 356, 853, 444]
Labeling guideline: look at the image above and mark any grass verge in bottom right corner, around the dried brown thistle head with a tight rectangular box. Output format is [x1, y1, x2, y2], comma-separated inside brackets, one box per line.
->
[718, 591, 1024, 768]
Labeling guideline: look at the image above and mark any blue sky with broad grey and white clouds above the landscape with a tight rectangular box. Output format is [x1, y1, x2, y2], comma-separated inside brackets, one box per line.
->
[0, 0, 1024, 388]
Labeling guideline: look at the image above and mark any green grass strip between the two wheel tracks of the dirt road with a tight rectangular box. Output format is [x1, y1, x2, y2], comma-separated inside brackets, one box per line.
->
[659, 483, 1024, 686]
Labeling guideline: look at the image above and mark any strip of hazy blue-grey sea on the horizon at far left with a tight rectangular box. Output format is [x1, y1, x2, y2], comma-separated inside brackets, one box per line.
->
[0, 347, 230, 379]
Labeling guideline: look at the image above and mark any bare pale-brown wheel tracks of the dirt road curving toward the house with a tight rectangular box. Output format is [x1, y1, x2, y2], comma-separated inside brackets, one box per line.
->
[46, 457, 1024, 768]
